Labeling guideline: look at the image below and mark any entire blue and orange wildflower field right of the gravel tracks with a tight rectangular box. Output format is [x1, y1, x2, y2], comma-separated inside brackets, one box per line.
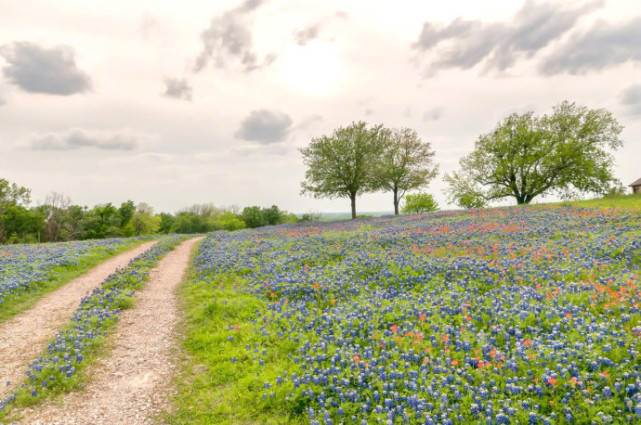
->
[166, 206, 641, 425]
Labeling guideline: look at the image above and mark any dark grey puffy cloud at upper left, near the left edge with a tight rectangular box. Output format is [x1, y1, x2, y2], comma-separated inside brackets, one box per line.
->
[0, 41, 91, 96]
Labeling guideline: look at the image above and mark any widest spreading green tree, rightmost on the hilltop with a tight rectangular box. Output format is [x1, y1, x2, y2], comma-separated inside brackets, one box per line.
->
[446, 102, 623, 205]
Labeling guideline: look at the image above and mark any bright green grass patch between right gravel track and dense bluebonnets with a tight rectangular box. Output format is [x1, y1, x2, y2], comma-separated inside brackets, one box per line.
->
[162, 272, 306, 425]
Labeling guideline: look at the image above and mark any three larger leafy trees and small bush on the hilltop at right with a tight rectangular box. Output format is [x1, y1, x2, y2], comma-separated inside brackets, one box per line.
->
[301, 101, 623, 218]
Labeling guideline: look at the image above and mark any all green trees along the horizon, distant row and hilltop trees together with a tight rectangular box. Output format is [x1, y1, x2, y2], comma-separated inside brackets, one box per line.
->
[0, 101, 623, 243]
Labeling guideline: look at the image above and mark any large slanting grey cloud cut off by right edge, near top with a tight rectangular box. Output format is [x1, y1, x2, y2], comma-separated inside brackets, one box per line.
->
[540, 17, 641, 75]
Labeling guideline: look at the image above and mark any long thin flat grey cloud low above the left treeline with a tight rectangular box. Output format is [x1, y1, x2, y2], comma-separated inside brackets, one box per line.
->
[31, 129, 138, 151]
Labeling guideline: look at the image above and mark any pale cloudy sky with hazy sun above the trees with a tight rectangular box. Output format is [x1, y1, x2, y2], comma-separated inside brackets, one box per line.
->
[0, 0, 641, 213]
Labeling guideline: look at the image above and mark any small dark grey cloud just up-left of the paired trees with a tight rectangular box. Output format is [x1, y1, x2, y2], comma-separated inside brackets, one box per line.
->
[235, 109, 292, 145]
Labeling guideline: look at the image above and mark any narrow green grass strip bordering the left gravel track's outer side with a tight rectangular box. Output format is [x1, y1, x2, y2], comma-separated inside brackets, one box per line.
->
[0, 239, 148, 323]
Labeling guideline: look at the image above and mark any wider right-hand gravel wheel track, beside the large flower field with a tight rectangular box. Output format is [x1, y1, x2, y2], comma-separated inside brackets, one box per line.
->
[20, 239, 199, 425]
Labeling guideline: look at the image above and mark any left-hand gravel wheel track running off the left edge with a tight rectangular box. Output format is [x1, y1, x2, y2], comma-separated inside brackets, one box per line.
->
[0, 242, 156, 399]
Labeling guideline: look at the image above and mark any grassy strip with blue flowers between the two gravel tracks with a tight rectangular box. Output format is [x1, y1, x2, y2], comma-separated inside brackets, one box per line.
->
[0, 236, 184, 411]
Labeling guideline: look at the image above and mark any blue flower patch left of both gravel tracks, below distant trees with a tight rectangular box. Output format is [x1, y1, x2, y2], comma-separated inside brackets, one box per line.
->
[0, 238, 130, 308]
